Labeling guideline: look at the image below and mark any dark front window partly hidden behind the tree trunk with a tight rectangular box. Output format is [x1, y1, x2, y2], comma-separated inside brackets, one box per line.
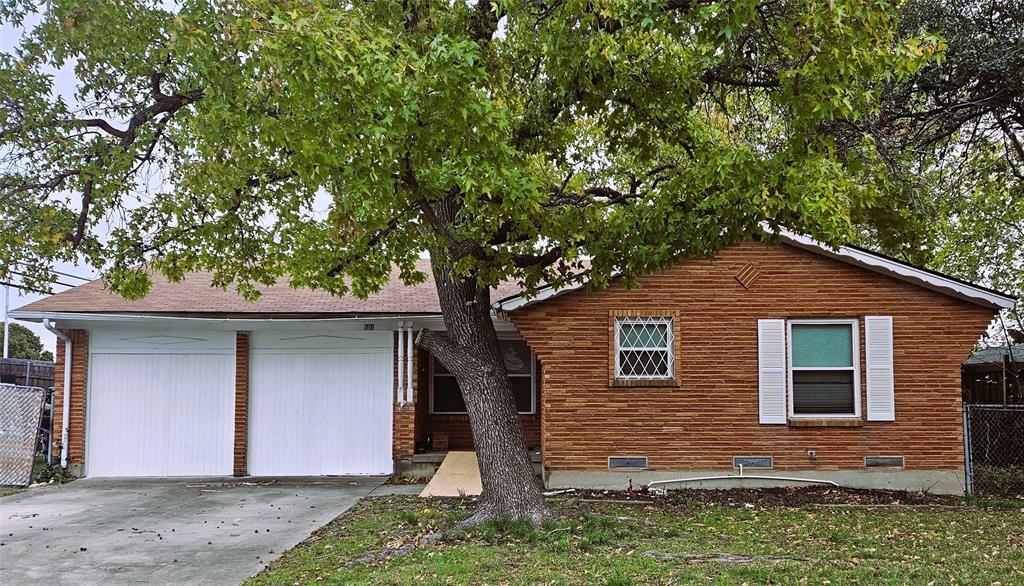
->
[430, 340, 535, 414]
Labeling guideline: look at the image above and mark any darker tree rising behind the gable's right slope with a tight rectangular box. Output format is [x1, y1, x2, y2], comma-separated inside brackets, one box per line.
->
[833, 0, 1024, 333]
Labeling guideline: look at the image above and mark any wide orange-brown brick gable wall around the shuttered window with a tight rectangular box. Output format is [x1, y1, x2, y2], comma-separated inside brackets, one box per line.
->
[511, 242, 993, 470]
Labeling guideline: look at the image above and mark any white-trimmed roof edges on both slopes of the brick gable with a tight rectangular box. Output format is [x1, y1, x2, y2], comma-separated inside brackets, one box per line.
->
[493, 229, 1017, 311]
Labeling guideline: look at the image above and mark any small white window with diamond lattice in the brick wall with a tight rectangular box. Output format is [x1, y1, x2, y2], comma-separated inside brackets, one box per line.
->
[615, 318, 673, 380]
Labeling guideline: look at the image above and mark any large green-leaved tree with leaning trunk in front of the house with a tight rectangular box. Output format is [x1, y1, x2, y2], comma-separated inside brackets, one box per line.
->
[0, 0, 939, 522]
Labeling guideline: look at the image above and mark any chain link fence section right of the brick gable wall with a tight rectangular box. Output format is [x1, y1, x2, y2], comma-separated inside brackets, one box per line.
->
[964, 405, 1024, 498]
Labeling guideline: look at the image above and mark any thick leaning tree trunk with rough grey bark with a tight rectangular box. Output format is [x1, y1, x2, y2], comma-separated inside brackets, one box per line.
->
[417, 251, 550, 529]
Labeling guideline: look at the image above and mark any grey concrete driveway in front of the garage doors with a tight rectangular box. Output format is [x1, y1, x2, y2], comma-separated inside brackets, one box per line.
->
[0, 476, 384, 586]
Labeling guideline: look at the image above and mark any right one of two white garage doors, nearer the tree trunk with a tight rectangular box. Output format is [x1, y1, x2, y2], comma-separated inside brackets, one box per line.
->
[249, 332, 392, 476]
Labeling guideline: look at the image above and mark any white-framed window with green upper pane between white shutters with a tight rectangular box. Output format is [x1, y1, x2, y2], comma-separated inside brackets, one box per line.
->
[790, 323, 857, 416]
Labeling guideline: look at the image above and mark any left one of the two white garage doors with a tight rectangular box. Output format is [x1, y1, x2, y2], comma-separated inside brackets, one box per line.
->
[85, 333, 234, 476]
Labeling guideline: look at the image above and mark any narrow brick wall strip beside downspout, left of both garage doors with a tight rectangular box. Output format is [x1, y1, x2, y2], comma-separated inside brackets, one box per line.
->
[50, 330, 89, 464]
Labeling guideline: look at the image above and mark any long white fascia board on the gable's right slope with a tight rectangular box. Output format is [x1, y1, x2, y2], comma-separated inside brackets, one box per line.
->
[766, 228, 1017, 309]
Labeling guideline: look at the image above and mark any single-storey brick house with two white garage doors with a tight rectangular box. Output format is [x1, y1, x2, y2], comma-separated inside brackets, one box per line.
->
[9, 234, 1015, 493]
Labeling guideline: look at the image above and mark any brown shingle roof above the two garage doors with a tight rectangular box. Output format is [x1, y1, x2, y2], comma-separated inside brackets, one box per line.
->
[11, 259, 520, 319]
